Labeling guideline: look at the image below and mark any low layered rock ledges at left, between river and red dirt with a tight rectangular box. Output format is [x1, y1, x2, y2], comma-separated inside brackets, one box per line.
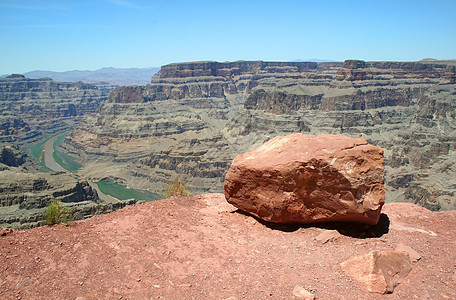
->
[0, 166, 135, 229]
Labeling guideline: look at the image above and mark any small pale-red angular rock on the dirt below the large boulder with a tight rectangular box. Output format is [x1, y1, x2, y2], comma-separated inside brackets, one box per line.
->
[341, 251, 412, 294]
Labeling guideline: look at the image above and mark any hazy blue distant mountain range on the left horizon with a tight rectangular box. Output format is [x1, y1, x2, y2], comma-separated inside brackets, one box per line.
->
[24, 67, 160, 85]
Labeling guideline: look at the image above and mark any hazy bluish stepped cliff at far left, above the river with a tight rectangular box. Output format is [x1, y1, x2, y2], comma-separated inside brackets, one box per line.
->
[0, 75, 107, 144]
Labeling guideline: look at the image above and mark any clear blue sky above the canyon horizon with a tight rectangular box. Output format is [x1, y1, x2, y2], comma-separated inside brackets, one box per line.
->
[0, 0, 456, 74]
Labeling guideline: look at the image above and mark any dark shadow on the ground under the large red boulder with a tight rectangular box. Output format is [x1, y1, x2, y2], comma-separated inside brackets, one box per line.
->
[233, 209, 390, 239]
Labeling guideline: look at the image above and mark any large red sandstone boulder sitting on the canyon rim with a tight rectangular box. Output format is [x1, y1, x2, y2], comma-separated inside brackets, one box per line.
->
[225, 133, 385, 225]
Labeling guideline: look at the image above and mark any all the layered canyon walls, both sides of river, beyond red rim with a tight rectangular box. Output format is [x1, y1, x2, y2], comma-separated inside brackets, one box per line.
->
[0, 60, 456, 228]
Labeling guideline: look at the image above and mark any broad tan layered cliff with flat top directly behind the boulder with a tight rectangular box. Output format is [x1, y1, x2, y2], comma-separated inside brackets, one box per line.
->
[65, 61, 456, 210]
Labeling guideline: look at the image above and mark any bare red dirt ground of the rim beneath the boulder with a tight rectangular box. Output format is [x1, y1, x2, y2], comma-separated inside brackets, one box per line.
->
[0, 194, 456, 300]
